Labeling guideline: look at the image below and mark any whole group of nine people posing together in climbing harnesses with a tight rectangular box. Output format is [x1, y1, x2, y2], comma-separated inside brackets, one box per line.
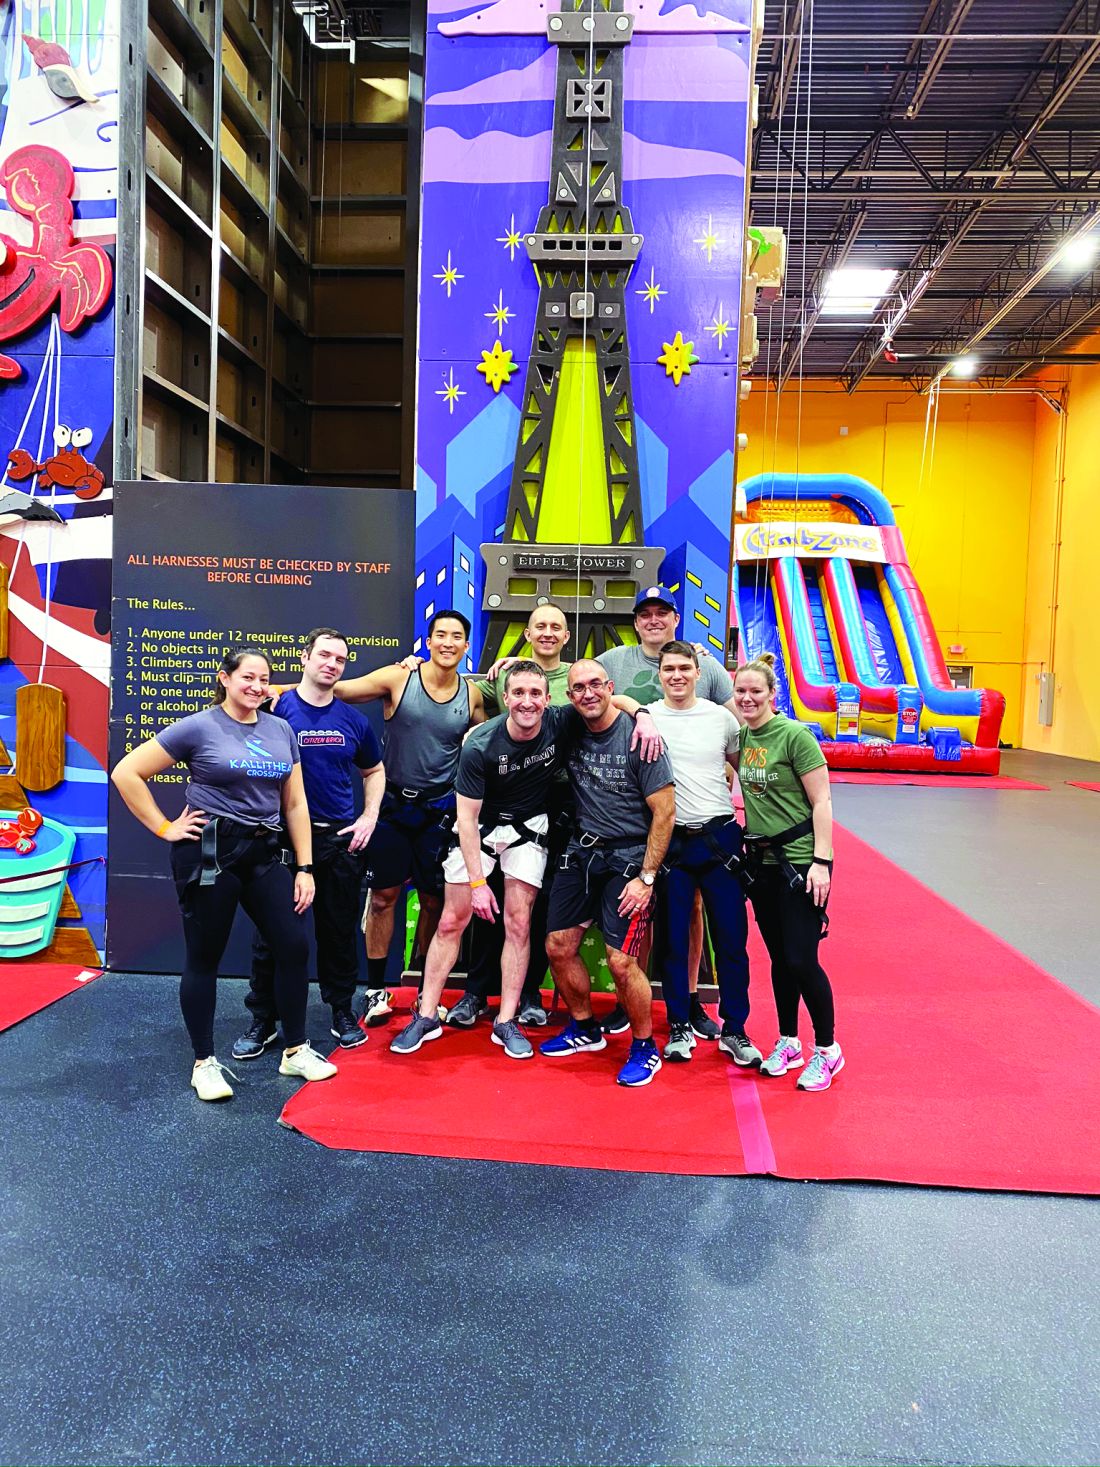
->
[111, 585, 845, 1100]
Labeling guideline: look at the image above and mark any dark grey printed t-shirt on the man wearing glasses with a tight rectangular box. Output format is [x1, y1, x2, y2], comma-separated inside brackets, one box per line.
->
[568, 713, 672, 845]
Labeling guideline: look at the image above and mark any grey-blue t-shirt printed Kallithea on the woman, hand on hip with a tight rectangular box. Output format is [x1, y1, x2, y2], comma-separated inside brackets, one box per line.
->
[157, 704, 299, 824]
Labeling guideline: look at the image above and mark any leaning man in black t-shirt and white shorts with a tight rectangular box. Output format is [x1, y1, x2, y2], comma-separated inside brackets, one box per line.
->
[390, 662, 582, 1059]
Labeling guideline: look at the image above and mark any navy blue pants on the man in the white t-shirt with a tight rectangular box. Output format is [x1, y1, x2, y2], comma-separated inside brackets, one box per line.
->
[659, 817, 748, 1030]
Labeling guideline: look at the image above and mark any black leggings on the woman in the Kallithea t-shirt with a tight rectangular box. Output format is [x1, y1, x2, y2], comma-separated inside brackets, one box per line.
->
[172, 836, 309, 1059]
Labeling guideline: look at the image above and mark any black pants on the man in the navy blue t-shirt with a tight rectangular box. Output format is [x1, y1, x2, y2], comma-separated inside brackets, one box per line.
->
[245, 824, 364, 1024]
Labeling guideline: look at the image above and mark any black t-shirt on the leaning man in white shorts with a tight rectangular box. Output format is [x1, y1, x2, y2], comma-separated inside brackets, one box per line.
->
[455, 707, 584, 829]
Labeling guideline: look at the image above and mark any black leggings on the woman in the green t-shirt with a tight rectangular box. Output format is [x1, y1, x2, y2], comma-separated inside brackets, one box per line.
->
[748, 864, 833, 1045]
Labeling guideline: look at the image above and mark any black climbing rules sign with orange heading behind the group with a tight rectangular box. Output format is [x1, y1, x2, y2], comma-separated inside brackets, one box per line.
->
[107, 483, 414, 974]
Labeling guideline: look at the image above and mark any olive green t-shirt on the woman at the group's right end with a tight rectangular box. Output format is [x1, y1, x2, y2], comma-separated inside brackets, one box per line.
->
[738, 713, 826, 866]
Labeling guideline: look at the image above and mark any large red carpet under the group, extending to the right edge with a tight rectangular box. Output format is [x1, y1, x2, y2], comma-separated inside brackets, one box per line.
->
[283, 830, 1100, 1194]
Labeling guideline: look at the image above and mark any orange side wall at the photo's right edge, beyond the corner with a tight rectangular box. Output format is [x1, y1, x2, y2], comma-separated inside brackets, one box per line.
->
[1024, 360, 1100, 760]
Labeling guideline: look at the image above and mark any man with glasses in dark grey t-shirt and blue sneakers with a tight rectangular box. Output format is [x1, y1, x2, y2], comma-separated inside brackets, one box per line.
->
[541, 659, 676, 1086]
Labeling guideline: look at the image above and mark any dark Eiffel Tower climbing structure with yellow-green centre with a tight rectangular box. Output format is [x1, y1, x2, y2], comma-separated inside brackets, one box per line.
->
[481, 0, 664, 666]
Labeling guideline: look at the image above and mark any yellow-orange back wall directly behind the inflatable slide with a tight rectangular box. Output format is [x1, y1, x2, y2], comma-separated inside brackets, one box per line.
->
[738, 377, 1038, 745]
